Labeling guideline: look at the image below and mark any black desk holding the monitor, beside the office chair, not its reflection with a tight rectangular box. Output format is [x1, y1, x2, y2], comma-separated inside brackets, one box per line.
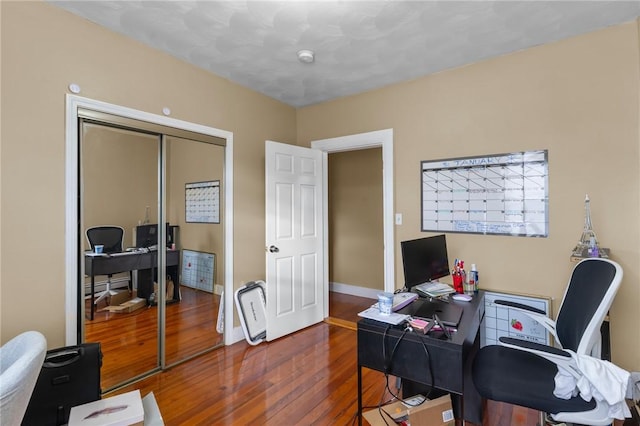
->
[358, 291, 484, 424]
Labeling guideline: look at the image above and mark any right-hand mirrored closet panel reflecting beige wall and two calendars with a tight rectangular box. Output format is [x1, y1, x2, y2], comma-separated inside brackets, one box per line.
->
[165, 137, 224, 365]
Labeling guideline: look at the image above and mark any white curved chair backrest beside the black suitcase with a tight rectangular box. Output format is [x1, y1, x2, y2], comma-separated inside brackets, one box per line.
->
[0, 331, 47, 425]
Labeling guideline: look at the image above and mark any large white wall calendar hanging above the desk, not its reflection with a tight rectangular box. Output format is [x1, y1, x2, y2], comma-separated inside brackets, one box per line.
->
[421, 150, 549, 237]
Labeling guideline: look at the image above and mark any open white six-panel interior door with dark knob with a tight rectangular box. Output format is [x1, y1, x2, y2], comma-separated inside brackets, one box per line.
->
[265, 141, 324, 340]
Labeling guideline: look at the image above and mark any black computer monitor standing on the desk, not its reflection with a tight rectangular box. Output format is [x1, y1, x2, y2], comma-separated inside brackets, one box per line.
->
[400, 234, 451, 290]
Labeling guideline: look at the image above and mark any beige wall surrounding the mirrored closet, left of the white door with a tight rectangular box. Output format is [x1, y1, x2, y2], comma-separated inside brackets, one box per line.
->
[0, 1, 296, 347]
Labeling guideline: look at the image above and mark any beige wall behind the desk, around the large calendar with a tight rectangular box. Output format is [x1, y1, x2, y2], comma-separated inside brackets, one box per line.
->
[297, 22, 640, 370]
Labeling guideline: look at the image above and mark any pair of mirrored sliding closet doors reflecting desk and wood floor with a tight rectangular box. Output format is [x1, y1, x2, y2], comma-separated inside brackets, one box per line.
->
[78, 112, 225, 391]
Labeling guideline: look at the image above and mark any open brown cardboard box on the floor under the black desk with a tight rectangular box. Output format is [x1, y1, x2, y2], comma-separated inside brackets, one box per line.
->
[364, 395, 456, 426]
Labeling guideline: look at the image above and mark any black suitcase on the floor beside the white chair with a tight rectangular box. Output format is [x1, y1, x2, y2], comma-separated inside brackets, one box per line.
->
[22, 343, 102, 426]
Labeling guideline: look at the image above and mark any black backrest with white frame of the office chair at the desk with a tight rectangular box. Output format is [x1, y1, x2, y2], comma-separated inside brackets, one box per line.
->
[556, 258, 622, 356]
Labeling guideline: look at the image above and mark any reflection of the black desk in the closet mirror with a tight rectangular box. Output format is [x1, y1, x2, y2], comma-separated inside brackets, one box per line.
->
[84, 250, 180, 320]
